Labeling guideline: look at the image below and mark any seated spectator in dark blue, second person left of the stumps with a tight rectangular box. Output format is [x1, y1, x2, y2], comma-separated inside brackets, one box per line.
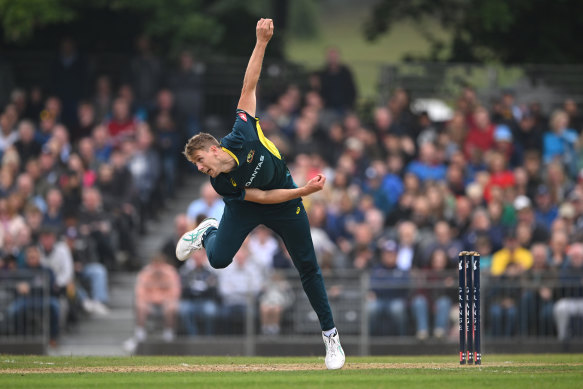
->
[368, 240, 409, 336]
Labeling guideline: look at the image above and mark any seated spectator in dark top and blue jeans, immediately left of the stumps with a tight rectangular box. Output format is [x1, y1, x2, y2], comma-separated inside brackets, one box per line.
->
[411, 248, 455, 340]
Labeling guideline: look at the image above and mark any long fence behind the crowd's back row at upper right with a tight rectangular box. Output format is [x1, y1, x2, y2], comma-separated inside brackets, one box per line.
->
[379, 63, 583, 112]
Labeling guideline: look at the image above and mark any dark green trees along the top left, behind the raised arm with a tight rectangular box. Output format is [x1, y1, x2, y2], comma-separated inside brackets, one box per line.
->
[0, 0, 283, 56]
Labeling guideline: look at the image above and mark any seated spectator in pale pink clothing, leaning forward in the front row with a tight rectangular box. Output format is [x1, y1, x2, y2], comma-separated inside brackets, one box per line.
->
[124, 254, 180, 352]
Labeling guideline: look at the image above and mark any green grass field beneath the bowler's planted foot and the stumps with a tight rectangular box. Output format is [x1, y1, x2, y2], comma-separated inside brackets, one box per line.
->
[0, 354, 583, 389]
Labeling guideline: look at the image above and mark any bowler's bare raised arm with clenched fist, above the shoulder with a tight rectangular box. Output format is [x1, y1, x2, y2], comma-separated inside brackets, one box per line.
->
[237, 19, 273, 116]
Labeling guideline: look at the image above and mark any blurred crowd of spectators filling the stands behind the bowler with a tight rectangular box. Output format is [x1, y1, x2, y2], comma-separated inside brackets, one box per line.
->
[0, 40, 583, 348]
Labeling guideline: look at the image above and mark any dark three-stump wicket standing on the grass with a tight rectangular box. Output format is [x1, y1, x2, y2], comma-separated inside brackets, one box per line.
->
[458, 251, 482, 365]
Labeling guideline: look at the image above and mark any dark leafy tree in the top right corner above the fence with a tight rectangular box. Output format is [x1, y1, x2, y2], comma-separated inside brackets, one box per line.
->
[364, 0, 583, 64]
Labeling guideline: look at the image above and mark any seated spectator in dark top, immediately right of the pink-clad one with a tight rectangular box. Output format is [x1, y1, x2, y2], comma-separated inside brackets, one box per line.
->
[179, 250, 219, 336]
